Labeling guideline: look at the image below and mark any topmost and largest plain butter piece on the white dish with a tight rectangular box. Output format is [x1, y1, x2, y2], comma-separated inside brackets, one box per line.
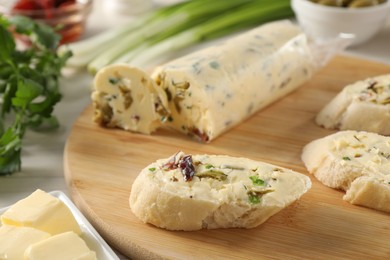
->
[1, 189, 81, 235]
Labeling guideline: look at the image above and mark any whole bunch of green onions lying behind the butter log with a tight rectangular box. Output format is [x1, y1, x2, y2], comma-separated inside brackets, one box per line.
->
[59, 0, 293, 74]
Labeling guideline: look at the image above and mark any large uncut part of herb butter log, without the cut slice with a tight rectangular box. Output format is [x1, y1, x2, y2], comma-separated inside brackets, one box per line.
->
[152, 21, 313, 142]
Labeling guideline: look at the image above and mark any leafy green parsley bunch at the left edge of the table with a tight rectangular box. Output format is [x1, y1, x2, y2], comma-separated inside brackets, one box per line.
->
[0, 15, 72, 175]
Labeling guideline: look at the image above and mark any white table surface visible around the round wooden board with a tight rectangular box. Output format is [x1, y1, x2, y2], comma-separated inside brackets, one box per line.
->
[0, 0, 390, 258]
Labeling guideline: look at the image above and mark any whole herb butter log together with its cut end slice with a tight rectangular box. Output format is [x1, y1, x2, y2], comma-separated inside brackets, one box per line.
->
[92, 21, 316, 142]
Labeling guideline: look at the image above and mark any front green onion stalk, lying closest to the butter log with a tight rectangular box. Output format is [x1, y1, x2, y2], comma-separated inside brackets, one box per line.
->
[122, 0, 293, 68]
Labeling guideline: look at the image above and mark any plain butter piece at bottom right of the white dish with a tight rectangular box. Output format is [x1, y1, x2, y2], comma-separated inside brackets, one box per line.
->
[24, 231, 97, 260]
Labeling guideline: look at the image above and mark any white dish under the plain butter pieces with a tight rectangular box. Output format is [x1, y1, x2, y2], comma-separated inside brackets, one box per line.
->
[0, 191, 119, 260]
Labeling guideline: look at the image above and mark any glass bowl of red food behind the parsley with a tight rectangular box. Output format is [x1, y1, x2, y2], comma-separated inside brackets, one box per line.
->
[0, 0, 93, 44]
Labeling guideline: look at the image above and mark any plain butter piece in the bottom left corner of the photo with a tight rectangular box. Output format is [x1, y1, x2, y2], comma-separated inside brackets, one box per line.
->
[0, 225, 50, 260]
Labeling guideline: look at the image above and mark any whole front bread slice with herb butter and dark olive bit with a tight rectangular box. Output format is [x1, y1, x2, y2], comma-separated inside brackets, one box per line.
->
[130, 152, 311, 231]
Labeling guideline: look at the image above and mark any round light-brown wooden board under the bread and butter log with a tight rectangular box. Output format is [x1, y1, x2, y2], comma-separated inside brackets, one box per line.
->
[64, 57, 390, 259]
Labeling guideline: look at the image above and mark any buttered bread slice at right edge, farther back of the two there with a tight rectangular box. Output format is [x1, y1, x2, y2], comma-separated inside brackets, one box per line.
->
[316, 74, 390, 135]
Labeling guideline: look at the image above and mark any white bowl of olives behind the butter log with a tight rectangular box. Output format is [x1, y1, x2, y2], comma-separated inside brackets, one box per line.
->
[291, 0, 390, 46]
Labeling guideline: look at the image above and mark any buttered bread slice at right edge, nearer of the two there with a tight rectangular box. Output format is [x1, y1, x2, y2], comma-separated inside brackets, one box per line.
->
[302, 131, 390, 212]
